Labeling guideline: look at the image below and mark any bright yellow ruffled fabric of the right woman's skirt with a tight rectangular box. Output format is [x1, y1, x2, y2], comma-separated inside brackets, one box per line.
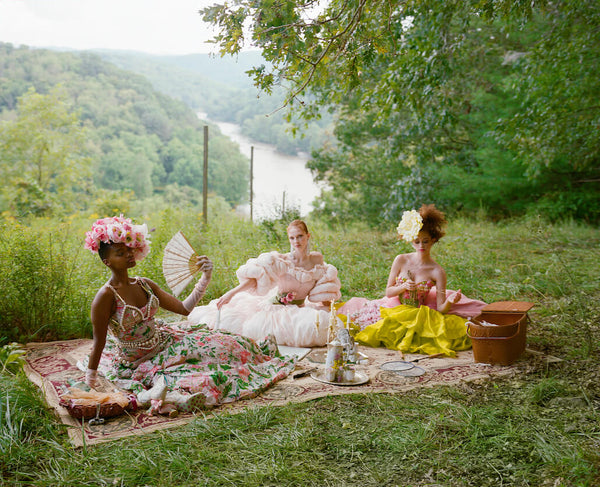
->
[355, 304, 471, 357]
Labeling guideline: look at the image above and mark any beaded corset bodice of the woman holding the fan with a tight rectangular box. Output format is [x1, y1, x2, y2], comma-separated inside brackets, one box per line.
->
[106, 277, 162, 363]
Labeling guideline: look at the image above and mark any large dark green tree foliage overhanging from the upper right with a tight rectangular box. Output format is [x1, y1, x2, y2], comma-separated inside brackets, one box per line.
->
[203, 0, 600, 223]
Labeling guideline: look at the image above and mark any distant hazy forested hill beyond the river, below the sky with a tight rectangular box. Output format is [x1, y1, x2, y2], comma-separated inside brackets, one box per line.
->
[93, 50, 332, 154]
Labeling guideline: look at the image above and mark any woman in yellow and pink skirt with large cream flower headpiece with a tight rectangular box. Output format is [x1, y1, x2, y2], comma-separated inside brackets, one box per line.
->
[338, 205, 486, 356]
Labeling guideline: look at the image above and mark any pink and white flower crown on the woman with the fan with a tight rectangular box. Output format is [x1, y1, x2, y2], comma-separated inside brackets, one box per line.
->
[84, 215, 150, 260]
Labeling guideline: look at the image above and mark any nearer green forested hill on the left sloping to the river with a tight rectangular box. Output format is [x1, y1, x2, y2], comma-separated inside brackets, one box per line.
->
[0, 43, 248, 217]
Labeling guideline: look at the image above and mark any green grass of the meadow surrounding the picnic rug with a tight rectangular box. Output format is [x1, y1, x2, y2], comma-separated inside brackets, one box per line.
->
[0, 212, 600, 486]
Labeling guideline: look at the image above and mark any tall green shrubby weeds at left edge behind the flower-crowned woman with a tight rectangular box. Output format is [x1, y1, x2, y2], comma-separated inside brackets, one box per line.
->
[0, 219, 91, 342]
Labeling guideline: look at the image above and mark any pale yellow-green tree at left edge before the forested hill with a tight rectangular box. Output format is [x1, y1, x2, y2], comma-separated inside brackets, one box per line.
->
[0, 87, 91, 215]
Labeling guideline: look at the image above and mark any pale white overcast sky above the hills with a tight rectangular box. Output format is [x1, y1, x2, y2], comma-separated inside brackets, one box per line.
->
[0, 0, 217, 54]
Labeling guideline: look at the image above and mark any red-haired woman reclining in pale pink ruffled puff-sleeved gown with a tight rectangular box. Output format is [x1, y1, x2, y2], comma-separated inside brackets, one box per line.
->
[188, 220, 341, 347]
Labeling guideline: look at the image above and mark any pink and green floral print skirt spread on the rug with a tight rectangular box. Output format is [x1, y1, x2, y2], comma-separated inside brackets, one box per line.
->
[98, 323, 295, 407]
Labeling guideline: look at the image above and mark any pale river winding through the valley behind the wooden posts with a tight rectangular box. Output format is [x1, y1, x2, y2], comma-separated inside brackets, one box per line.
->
[199, 114, 321, 220]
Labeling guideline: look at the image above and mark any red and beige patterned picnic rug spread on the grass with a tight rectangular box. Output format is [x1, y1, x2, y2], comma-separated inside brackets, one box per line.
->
[25, 339, 528, 446]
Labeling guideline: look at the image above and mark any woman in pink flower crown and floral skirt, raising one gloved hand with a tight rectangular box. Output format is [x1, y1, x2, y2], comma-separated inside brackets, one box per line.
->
[85, 216, 294, 414]
